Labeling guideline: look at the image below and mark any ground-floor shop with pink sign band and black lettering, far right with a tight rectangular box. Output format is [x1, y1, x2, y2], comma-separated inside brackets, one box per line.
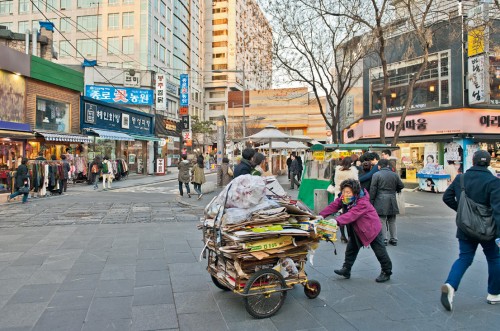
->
[343, 108, 500, 184]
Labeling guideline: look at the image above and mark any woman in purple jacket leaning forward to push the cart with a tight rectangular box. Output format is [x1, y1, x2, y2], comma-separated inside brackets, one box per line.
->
[319, 179, 392, 283]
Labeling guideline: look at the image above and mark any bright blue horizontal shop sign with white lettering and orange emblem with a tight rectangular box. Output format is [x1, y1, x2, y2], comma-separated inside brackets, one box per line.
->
[85, 85, 153, 106]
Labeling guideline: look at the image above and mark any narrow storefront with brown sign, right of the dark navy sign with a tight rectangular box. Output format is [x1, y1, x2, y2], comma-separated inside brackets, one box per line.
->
[155, 115, 181, 167]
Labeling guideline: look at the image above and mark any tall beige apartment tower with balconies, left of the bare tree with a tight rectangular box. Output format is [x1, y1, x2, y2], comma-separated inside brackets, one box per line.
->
[204, 0, 272, 124]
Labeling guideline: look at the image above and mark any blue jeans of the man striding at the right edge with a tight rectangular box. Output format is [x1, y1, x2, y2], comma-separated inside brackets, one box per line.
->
[446, 239, 500, 295]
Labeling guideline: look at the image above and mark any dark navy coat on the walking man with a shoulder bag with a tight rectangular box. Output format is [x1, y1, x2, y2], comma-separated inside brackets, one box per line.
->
[443, 166, 500, 240]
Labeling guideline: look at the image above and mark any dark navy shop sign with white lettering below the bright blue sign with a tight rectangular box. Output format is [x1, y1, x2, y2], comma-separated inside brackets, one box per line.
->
[80, 97, 154, 136]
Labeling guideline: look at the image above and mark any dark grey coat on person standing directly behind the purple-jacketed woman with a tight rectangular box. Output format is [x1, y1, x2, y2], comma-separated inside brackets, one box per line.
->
[370, 167, 405, 215]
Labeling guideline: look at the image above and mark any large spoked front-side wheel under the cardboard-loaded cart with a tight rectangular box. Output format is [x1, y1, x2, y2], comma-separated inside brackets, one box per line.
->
[243, 269, 287, 318]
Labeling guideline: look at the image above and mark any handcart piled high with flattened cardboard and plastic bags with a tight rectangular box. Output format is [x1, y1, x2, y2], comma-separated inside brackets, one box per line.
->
[199, 175, 337, 318]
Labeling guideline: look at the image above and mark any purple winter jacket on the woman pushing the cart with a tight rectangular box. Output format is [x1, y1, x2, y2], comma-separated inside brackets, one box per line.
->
[319, 190, 382, 246]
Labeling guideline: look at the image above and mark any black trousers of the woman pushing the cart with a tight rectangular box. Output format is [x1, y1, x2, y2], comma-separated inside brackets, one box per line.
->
[344, 231, 392, 275]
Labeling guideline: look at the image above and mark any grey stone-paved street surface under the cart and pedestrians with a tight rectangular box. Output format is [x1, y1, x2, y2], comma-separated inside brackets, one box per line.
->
[0, 173, 500, 331]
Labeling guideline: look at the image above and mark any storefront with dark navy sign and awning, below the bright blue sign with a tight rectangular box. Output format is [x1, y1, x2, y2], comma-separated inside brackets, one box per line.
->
[80, 97, 160, 174]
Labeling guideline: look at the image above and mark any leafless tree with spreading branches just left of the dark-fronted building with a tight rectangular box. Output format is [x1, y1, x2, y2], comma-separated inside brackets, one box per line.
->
[263, 0, 366, 142]
